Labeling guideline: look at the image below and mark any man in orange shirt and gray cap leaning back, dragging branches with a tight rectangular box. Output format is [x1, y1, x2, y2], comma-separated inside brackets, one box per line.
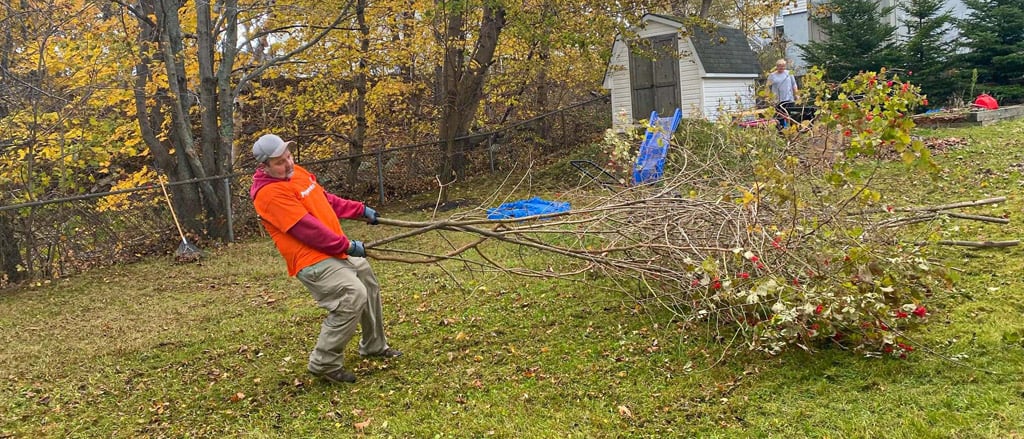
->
[249, 134, 401, 383]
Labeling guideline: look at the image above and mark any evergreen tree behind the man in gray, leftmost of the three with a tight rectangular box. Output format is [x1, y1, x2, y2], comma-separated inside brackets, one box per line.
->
[798, 0, 896, 80]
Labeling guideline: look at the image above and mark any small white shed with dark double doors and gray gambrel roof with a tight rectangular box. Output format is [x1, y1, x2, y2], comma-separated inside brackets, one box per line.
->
[603, 13, 760, 129]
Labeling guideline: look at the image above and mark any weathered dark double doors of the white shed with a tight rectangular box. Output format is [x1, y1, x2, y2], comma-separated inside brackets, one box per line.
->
[630, 35, 680, 120]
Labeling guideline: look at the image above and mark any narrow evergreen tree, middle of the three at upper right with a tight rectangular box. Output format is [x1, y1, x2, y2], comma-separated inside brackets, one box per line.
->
[900, 0, 956, 103]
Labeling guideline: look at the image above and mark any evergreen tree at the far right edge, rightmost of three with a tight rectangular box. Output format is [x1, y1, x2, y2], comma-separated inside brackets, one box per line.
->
[957, 0, 1024, 100]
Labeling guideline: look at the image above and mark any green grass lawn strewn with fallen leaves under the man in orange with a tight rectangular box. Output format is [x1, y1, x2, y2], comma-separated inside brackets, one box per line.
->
[0, 121, 1024, 438]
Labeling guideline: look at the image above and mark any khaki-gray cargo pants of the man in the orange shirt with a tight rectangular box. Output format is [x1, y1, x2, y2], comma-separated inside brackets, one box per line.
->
[296, 257, 388, 375]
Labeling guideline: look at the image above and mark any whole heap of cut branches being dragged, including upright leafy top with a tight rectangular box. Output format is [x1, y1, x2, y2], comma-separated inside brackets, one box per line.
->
[368, 69, 1016, 356]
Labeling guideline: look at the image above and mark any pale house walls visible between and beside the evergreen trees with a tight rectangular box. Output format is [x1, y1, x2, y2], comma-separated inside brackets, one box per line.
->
[774, 0, 968, 73]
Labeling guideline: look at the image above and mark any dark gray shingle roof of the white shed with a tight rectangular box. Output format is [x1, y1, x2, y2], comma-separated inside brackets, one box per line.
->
[651, 13, 761, 75]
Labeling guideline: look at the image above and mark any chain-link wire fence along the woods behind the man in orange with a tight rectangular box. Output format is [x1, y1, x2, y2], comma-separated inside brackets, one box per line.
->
[0, 97, 610, 289]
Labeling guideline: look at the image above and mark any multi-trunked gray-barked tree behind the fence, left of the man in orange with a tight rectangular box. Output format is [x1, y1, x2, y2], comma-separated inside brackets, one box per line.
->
[122, 0, 351, 238]
